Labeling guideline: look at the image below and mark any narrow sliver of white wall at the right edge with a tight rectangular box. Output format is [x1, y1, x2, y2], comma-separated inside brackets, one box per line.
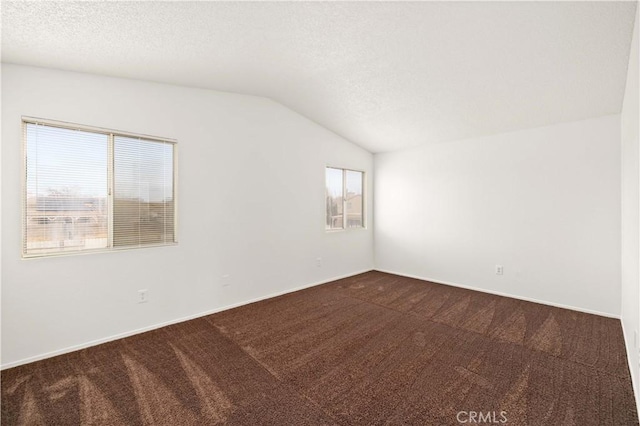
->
[621, 4, 640, 405]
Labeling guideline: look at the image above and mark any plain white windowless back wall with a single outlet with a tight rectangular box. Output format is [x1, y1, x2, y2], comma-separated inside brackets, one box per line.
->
[374, 115, 620, 315]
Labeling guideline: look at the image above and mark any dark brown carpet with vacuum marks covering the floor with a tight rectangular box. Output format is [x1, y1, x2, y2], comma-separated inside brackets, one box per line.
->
[2, 272, 638, 426]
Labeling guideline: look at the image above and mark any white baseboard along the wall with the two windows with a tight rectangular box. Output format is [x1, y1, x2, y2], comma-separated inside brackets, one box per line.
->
[0, 269, 371, 370]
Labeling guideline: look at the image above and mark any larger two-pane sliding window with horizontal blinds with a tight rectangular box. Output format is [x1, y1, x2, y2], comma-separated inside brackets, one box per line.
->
[22, 119, 176, 257]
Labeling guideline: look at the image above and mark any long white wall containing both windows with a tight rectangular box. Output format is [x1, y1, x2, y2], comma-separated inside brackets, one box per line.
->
[2, 65, 373, 367]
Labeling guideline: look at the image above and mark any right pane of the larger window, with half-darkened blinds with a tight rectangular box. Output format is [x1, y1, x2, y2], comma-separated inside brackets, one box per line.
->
[113, 136, 175, 247]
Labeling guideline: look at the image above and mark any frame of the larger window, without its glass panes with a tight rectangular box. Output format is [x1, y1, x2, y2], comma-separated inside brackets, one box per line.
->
[21, 116, 178, 259]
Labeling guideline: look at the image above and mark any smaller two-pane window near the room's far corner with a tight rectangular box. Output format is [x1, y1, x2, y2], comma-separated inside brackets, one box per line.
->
[325, 167, 364, 229]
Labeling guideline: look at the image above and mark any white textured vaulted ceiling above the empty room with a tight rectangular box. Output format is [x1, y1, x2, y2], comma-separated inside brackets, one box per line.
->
[2, 1, 636, 152]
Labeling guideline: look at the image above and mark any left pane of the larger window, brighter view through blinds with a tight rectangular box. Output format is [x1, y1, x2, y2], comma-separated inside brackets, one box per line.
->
[23, 123, 108, 254]
